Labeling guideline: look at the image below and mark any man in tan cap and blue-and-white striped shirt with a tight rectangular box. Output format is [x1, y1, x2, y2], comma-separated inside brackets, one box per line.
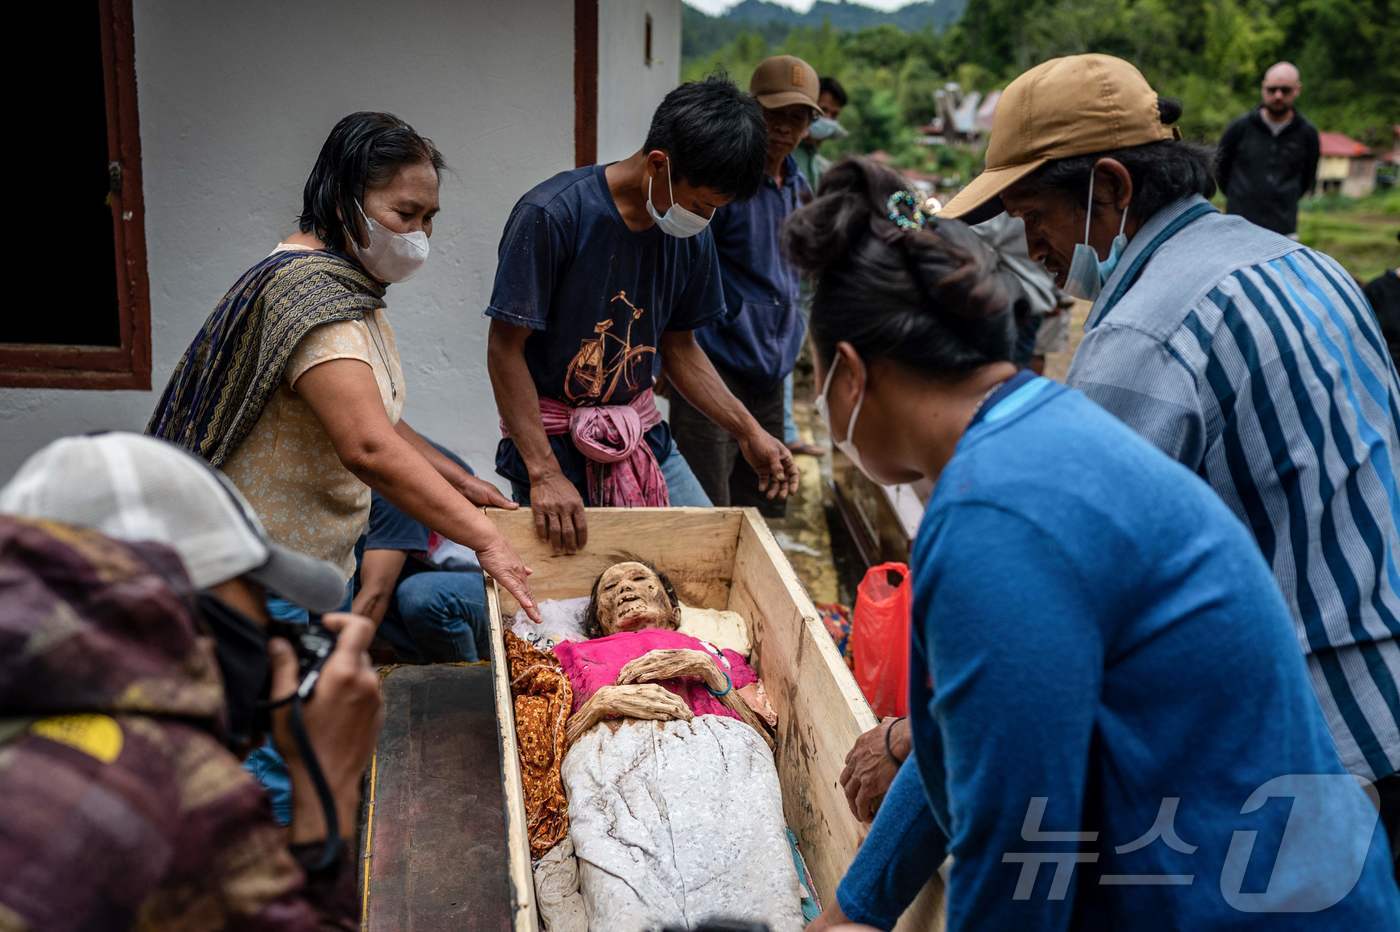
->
[938, 55, 1400, 834]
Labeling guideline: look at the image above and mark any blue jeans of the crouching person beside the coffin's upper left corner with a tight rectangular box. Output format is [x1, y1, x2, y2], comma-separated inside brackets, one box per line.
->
[379, 571, 491, 663]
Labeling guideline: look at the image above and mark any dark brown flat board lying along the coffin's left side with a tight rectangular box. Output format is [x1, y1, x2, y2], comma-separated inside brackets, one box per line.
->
[363, 663, 512, 932]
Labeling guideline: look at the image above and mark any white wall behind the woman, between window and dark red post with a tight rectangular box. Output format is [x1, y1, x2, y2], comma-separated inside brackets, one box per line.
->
[0, 0, 574, 480]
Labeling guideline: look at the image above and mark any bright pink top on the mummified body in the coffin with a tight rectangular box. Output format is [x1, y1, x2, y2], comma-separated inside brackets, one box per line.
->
[554, 628, 759, 718]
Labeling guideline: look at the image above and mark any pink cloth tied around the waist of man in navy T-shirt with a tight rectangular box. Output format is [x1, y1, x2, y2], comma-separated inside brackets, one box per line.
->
[501, 389, 671, 508]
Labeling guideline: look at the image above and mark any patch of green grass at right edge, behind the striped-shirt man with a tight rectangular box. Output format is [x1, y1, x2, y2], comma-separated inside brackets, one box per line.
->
[1298, 188, 1400, 283]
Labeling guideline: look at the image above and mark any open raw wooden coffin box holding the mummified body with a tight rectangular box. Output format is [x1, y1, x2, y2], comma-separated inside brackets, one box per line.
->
[487, 508, 941, 932]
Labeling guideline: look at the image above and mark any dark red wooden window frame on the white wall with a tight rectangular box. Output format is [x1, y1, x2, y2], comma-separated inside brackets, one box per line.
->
[0, 0, 151, 389]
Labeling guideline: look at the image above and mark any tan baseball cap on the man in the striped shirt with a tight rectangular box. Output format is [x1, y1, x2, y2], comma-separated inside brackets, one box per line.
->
[938, 55, 1180, 223]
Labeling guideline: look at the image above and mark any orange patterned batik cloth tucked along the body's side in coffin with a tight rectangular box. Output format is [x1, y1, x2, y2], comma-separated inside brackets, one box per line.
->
[505, 631, 574, 858]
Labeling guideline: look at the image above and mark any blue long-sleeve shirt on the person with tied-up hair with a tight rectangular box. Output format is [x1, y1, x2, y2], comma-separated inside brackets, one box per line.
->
[837, 379, 1400, 931]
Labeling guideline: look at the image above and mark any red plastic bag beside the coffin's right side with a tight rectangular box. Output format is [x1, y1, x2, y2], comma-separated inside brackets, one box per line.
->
[851, 563, 914, 718]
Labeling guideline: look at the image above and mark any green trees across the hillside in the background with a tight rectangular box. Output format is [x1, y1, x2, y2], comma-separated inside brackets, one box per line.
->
[683, 0, 1400, 161]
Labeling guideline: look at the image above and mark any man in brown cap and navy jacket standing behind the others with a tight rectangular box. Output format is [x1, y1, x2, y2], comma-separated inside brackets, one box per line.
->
[666, 55, 822, 516]
